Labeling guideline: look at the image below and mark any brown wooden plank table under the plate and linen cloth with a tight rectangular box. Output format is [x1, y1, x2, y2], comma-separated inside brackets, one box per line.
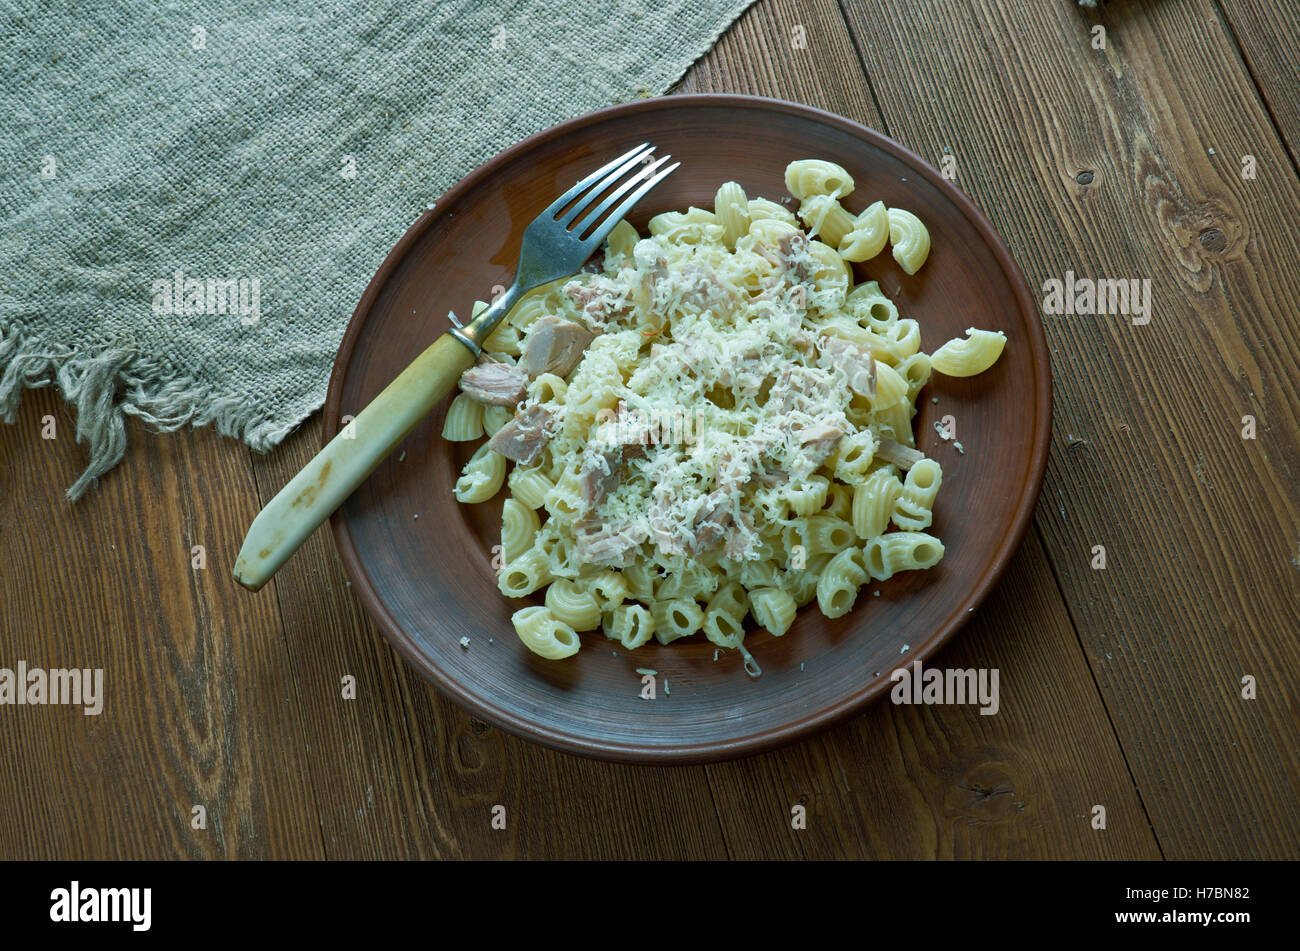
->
[0, 0, 1300, 859]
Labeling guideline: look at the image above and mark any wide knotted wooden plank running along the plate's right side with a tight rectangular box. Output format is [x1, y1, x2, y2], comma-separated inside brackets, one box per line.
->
[845, 0, 1300, 859]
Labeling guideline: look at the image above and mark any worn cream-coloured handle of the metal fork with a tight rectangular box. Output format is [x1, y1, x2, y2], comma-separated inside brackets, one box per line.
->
[235, 334, 475, 591]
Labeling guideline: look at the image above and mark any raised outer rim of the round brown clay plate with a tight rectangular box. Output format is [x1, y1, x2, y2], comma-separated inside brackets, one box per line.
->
[321, 92, 1053, 765]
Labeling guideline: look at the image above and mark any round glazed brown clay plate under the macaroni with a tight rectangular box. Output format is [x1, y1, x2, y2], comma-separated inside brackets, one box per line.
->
[325, 95, 1052, 763]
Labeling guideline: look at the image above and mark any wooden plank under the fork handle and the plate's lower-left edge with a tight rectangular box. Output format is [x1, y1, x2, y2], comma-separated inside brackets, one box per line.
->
[244, 418, 725, 859]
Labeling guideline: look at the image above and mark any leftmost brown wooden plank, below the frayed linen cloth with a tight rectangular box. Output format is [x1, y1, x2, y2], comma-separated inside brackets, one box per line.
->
[0, 390, 324, 859]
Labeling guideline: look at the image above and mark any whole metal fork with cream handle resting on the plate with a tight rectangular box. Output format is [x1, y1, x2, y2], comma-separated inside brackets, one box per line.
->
[234, 143, 681, 591]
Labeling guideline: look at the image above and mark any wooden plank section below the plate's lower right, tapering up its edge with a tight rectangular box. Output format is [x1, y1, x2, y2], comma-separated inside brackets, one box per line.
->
[709, 535, 1161, 859]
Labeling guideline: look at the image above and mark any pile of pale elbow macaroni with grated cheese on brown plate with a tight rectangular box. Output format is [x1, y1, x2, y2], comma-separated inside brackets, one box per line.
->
[443, 159, 1006, 659]
